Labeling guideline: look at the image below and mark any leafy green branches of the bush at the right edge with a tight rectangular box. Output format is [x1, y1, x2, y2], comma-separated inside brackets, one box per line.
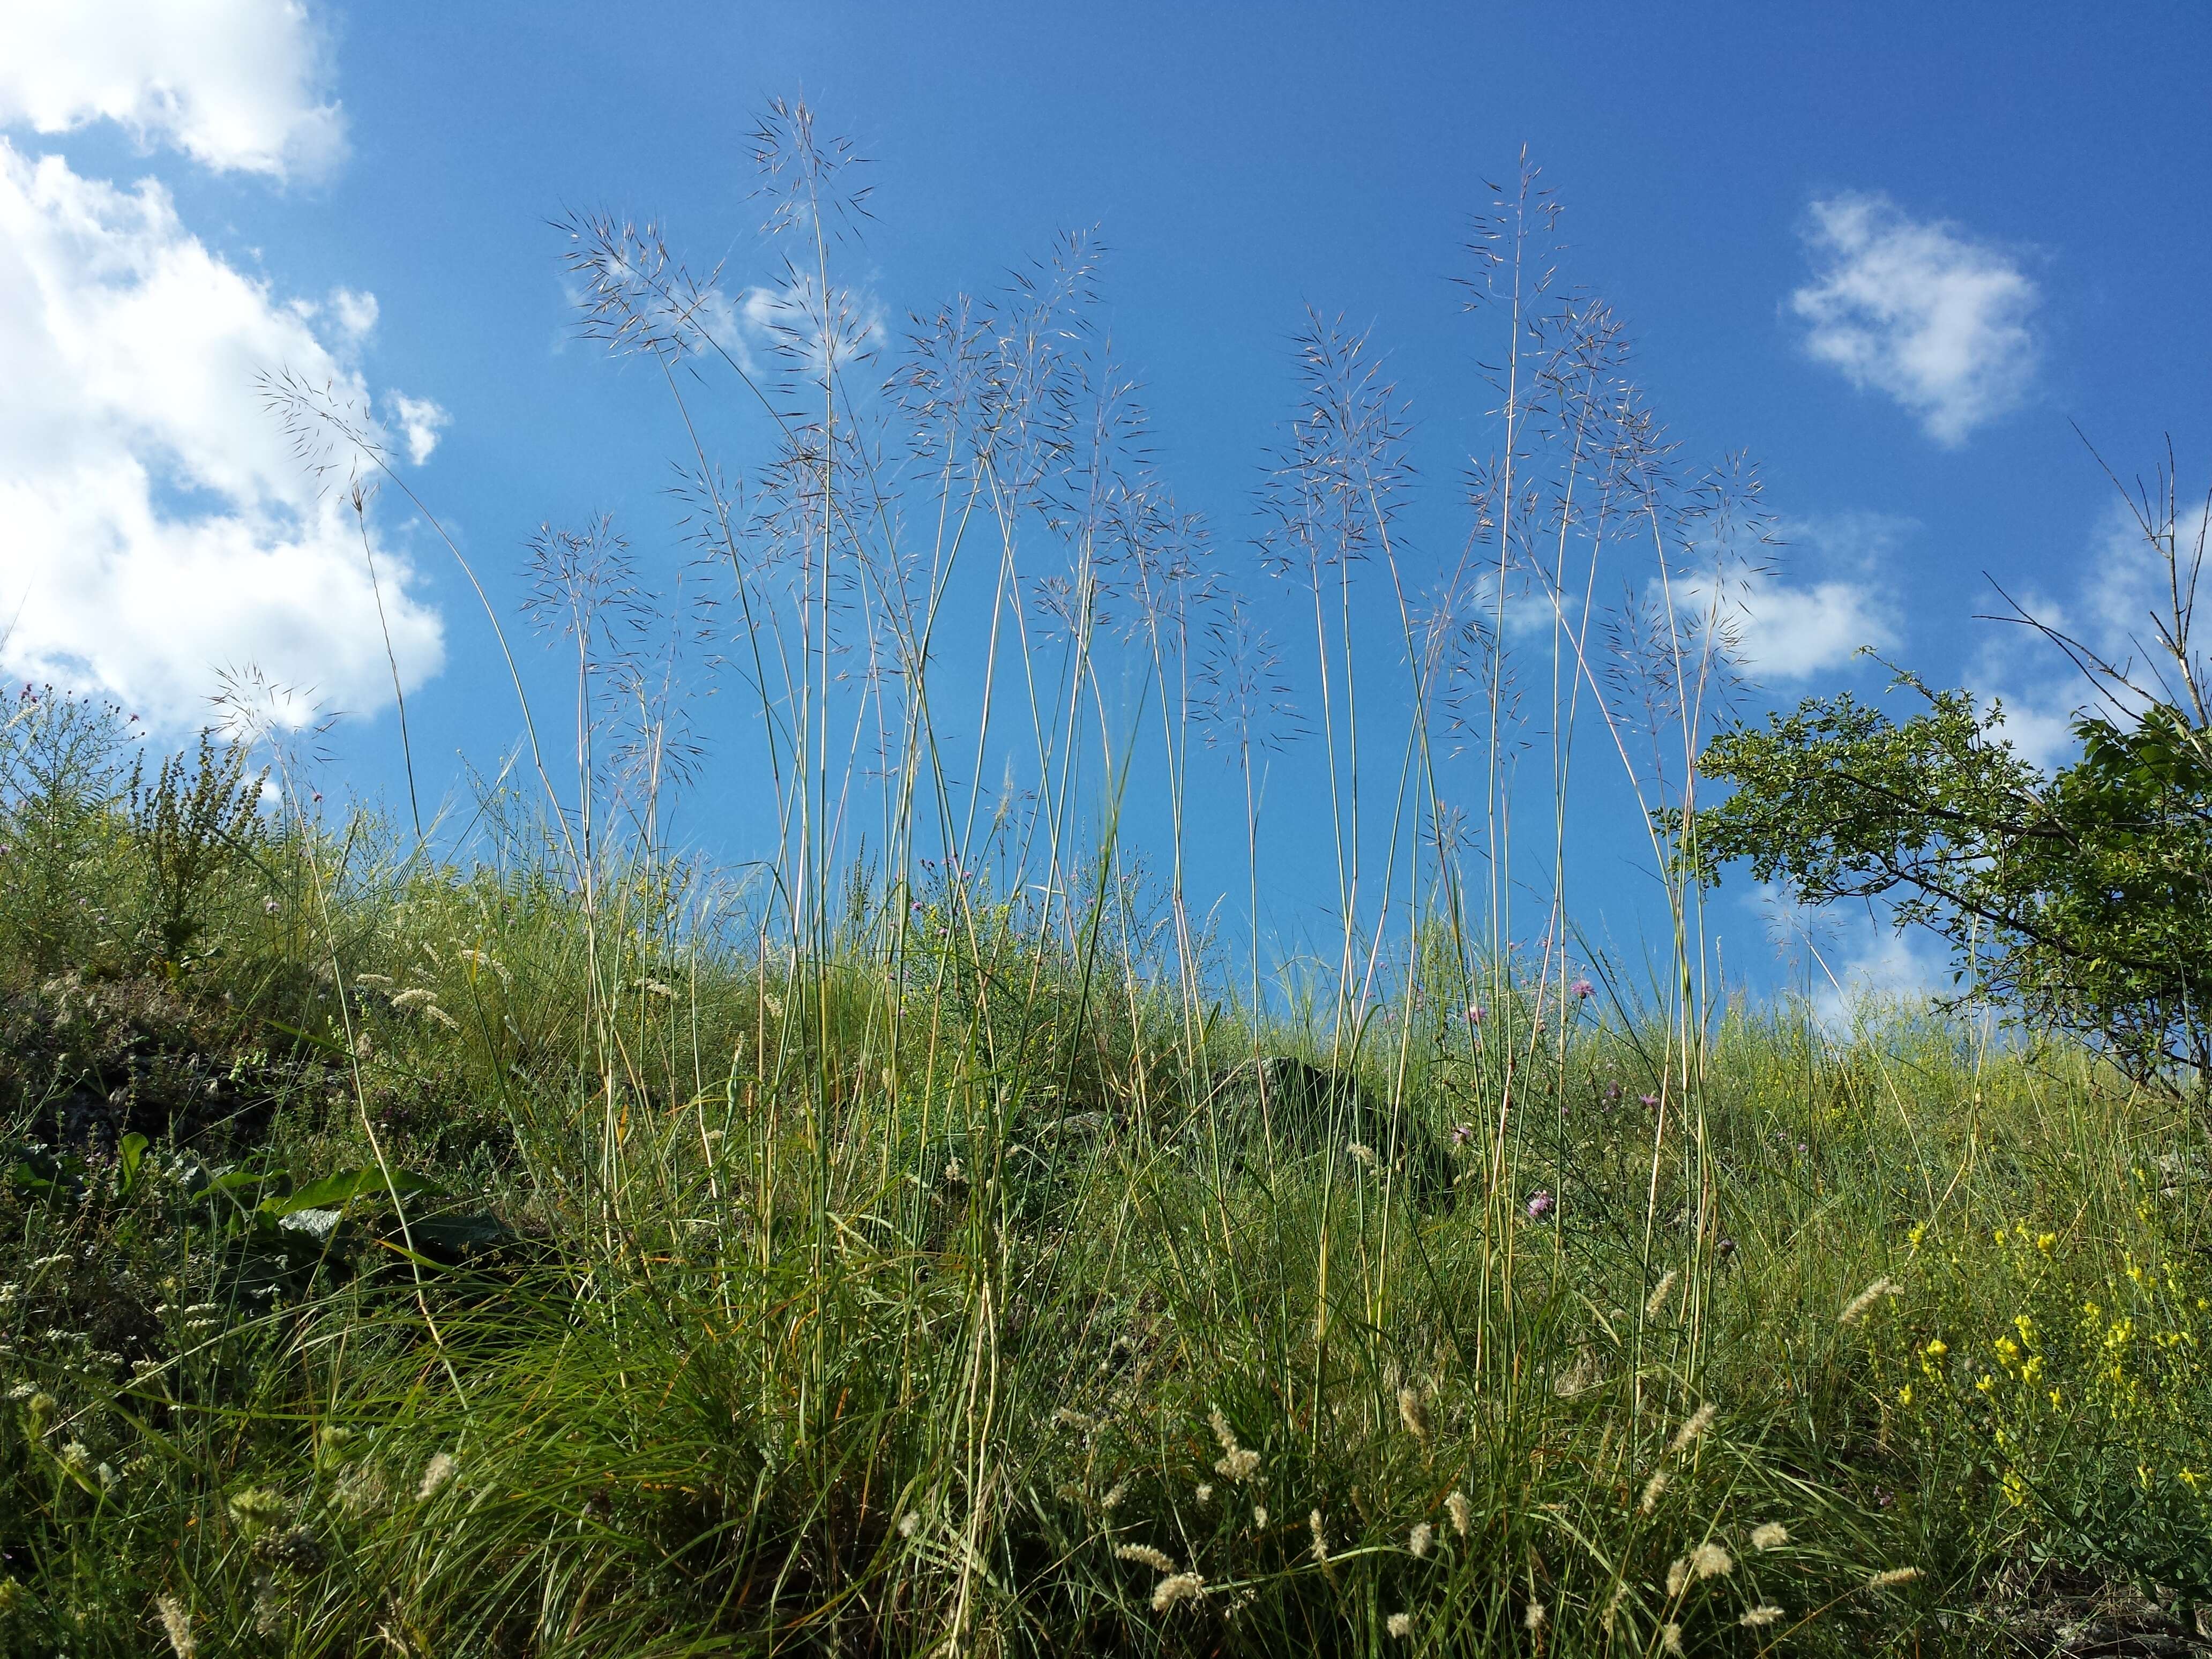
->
[1668, 675, 2212, 1084]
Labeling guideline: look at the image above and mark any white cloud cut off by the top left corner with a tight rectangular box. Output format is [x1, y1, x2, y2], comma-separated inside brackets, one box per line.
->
[0, 0, 345, 179]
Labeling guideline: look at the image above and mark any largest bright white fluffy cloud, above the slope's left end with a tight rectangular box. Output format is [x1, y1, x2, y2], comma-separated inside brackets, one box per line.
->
[0, 139, 443, 728]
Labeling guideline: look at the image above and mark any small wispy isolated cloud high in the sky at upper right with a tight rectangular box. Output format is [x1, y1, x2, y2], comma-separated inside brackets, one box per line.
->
[1790, 195, 2039, 447]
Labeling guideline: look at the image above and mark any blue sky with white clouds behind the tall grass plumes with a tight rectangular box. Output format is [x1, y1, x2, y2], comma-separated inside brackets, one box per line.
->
[0, 0, 2212, 999]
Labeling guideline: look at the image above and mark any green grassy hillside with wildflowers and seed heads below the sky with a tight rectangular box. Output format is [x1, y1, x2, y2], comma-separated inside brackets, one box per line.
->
[0, 708, 2212, 1657]
